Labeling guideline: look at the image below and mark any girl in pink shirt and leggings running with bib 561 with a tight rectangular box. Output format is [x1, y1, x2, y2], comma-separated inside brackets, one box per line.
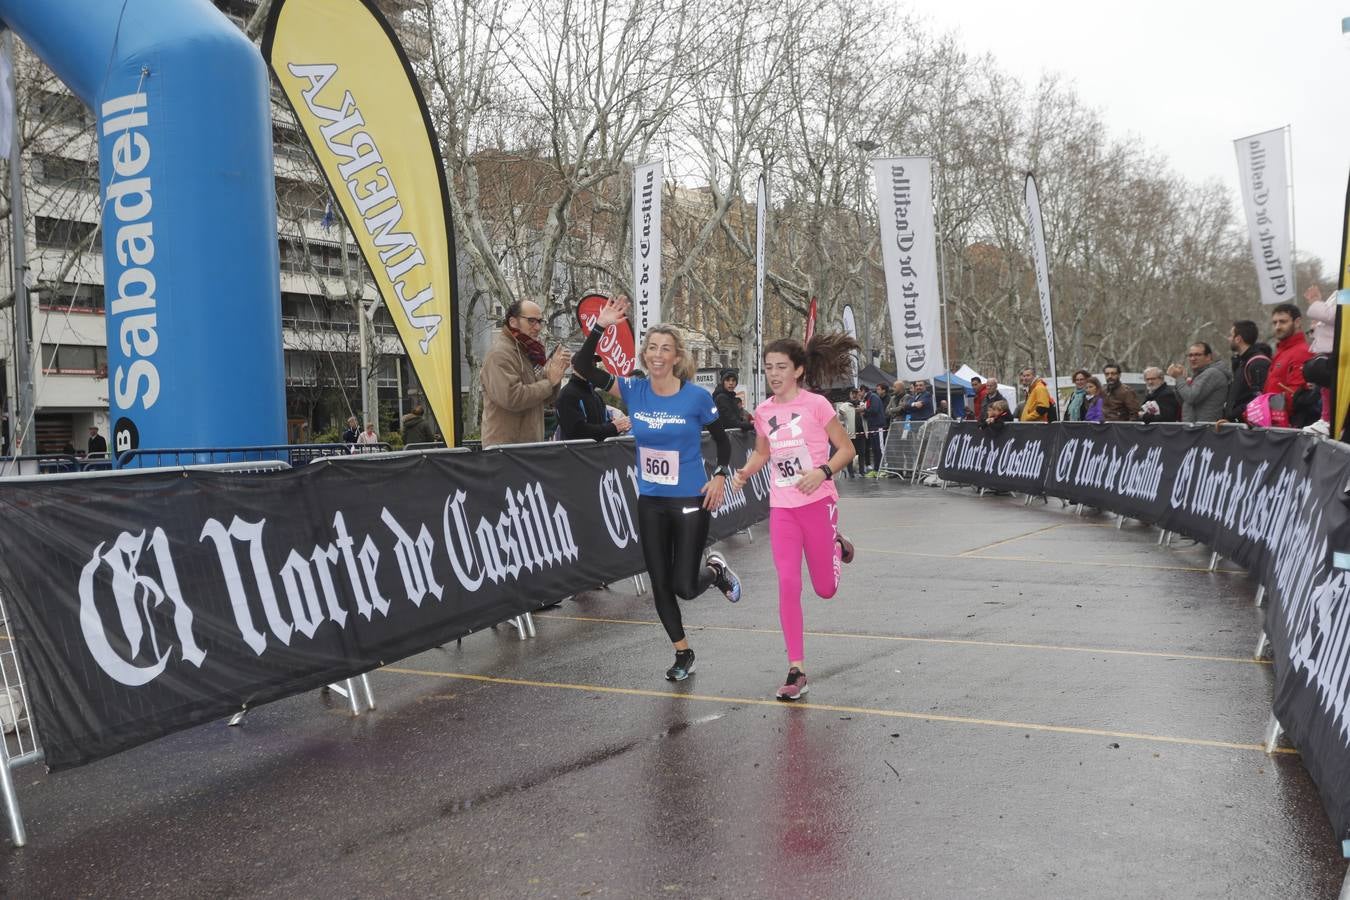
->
[732, 335, 857, 700]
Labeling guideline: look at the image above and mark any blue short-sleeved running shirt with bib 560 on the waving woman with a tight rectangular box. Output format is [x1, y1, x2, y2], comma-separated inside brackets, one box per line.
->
[618, 378, 717, 497]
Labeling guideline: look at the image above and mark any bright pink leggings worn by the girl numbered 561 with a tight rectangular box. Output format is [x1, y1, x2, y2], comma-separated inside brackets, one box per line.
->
[768, 497, 842, 663]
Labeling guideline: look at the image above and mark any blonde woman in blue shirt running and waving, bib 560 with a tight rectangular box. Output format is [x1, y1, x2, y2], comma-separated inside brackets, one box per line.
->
[572, 297, 741, 681]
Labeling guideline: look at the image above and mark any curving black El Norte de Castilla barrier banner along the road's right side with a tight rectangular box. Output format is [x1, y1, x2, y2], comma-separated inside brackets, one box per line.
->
[938, 422, 1350, 841]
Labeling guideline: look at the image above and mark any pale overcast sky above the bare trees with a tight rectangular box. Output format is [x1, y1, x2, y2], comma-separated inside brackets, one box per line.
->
[907, 0, 1350, 277]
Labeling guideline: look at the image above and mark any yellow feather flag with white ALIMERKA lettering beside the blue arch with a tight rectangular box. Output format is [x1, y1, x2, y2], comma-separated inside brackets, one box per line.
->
[262, 0, 460, 445]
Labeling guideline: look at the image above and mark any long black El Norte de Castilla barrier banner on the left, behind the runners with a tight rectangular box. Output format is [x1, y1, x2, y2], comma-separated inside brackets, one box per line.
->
[0, 433, 768, 769]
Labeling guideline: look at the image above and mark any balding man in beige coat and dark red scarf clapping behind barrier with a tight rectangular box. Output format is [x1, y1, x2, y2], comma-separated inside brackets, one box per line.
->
[481, 300, 572, 447]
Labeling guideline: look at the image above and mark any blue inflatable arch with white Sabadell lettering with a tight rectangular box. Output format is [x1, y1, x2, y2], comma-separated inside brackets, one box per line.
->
[0, 0, 286, 453]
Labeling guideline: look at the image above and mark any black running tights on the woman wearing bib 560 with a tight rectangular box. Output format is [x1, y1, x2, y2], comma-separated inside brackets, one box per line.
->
[637, 497, 714, 644]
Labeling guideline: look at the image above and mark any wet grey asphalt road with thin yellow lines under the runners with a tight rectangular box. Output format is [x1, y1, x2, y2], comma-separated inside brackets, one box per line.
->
[0, 480, 1345, 899]
